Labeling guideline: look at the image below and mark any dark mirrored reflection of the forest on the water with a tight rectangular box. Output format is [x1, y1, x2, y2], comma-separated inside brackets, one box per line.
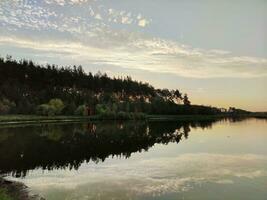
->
[0, 121, 218, 176]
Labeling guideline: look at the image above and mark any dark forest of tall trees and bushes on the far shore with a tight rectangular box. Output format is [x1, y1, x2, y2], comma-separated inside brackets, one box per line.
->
[0, 56, 247, 118]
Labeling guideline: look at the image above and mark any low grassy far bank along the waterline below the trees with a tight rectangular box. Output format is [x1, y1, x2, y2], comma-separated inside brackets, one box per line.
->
[0, 113, 267, 125]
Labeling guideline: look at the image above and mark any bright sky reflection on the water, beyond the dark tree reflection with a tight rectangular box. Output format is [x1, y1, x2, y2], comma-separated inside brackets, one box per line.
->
[8, 120, 267, 200]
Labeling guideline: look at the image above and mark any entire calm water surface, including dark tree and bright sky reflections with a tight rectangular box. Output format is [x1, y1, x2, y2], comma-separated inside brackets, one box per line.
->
[0, 119, 267, 200]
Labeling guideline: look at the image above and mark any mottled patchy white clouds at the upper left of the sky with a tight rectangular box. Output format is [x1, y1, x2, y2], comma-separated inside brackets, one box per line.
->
[0, 0, 149, 33]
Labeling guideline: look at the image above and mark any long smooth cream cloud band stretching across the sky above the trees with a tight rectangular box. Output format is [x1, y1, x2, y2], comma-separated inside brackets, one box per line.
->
[0, 32, 267, 78]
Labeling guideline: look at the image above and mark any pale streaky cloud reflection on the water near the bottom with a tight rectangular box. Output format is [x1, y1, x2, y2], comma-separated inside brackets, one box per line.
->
[10, 153, 267, 196]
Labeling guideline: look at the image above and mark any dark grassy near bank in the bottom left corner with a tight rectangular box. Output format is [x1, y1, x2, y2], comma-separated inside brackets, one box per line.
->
[0, 177, 45, 200]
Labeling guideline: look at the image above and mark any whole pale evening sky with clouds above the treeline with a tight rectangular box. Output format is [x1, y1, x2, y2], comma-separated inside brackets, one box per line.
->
[0, 0, 267, 111]
